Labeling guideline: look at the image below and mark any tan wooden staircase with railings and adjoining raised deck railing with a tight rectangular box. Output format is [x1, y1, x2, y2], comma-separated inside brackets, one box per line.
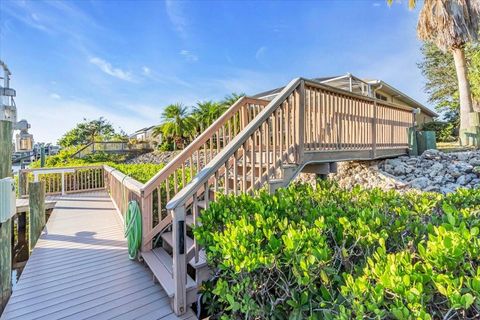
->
[133, 78, 413, 315]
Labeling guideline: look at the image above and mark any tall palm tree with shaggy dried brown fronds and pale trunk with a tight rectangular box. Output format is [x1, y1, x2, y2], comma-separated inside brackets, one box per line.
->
[387, 0, 480, 144]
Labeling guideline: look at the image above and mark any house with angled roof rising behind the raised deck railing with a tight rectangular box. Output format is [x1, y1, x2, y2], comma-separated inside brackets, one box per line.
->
[254, 73, 438, 124]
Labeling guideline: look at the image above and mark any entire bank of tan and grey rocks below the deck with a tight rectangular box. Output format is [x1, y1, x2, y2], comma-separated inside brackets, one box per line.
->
[299, 150, 480, 194]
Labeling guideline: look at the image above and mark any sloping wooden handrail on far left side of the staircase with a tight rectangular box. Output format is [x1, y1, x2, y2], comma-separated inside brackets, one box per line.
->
[142, 97, 268, 194]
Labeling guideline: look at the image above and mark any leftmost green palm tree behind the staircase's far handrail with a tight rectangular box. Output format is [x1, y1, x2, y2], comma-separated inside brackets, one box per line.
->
[153, 103, 195, 150]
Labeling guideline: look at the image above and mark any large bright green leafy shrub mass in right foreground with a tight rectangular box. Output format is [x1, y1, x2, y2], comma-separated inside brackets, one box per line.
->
[194, 183, 480, 319]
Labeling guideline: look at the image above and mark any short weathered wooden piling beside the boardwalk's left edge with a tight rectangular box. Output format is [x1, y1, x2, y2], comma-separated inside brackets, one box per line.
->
[28, 181, 46, 250]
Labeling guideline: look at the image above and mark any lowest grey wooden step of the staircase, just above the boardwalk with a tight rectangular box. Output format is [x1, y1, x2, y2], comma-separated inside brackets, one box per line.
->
[142, 248, 197, 298]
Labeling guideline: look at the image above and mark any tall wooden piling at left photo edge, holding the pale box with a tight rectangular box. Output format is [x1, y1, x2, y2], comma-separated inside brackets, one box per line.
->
[0, 120, 13, 313]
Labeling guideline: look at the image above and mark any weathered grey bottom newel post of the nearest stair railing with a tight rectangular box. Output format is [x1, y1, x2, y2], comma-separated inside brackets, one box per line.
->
[172, 205, 187, 315]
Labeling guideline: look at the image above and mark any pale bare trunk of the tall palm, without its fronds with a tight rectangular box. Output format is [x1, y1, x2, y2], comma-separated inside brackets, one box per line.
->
[452, 48, 473, 145]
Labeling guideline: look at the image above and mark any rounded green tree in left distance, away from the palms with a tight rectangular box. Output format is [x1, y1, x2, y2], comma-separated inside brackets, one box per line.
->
[58, 117, 126, 148]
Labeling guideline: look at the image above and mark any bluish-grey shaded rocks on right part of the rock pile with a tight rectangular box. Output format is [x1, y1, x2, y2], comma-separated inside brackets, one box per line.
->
[379, 150, 480, 193]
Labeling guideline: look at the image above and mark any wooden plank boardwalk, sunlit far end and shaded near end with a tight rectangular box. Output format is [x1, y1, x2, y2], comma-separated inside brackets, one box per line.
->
[1, 191, 196, 320]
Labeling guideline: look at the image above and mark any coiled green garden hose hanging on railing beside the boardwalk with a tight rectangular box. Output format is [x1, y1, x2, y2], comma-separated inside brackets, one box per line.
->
[125, 200, 142, 260]
